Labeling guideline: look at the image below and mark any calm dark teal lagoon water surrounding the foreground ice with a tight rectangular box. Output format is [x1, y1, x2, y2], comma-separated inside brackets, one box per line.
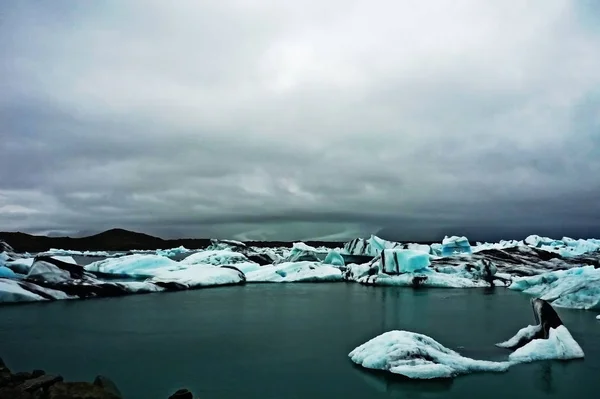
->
[0, 283, 600, 399]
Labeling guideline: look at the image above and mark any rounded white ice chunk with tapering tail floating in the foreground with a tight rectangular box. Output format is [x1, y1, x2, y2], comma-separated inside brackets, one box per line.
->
[348, 331, 510, 379]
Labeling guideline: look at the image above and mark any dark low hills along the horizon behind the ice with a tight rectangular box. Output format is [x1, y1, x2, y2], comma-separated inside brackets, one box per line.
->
[0, 229, 343, 252]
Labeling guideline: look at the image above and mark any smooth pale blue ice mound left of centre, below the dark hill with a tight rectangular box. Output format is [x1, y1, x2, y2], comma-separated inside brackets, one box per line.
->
[85, 254, 183, 278]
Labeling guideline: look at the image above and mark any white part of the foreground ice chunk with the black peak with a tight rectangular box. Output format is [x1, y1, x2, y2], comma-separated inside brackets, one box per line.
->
[508, 325, 584, 363]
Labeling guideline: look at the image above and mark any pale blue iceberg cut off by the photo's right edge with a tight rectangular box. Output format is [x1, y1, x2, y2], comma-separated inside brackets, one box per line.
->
[509, 266, 600, 309]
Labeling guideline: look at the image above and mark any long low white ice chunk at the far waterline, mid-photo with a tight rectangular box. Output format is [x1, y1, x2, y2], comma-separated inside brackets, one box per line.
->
[246, 262, 342, 283]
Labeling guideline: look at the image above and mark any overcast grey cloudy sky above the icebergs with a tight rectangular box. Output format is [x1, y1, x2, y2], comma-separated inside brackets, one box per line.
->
[0, 0, 600, 241]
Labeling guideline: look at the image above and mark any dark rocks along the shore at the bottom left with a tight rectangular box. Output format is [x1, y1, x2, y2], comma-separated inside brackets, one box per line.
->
[0, 358, 194, 399]
